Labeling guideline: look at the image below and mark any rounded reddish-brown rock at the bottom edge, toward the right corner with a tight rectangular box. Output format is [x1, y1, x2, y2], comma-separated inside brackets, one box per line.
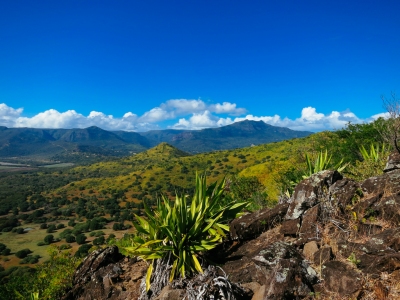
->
[322, 261, 362, 297]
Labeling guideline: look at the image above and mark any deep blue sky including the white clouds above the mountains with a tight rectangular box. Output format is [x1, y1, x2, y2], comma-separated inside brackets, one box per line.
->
[0, 0, 400, 131]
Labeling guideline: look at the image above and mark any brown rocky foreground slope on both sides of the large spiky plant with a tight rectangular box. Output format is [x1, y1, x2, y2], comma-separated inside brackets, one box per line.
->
[64, 154, 400, 300]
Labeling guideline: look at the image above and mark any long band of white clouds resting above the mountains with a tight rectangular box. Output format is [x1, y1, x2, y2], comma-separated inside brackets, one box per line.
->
[0, 99, 386, 131]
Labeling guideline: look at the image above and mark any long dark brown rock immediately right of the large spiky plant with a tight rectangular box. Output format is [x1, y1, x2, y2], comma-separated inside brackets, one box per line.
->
[229, 203, 289, 240]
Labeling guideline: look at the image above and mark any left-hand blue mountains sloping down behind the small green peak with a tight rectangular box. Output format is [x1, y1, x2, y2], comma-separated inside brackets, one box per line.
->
[0, 126, 146, 161]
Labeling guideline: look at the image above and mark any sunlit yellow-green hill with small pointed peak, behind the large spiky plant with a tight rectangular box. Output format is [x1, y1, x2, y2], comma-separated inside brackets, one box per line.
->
[49, 134, 322, 202]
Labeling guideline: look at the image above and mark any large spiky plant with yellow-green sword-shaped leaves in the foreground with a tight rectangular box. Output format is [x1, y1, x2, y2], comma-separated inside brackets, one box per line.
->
[125, 174, 248, 291]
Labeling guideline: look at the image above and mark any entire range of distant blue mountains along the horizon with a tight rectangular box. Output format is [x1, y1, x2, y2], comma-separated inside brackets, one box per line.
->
[0, 120, 312, 158]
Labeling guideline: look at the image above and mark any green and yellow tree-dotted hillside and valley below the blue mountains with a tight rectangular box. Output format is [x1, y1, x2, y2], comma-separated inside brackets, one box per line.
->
[0, 120, 388, 298]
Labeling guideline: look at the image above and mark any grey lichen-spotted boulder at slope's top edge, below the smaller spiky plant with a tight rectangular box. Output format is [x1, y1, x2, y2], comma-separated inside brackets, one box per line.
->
[285, 170, 343, 220]
